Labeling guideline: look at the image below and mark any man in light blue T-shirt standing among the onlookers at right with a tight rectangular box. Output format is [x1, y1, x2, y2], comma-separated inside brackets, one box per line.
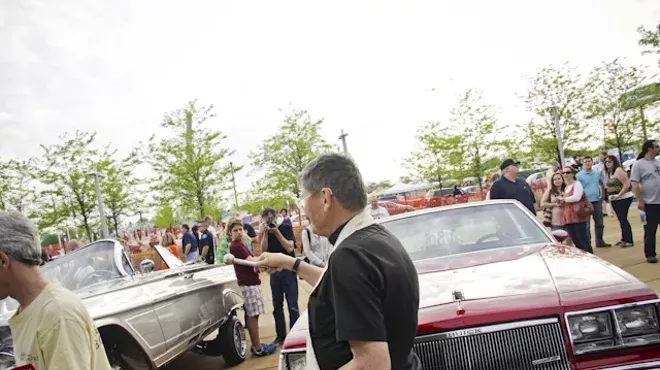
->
[577, 156, 612, 248]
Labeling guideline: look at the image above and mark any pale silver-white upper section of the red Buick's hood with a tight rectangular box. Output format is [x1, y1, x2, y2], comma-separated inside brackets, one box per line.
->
[416, 245, 637, 308]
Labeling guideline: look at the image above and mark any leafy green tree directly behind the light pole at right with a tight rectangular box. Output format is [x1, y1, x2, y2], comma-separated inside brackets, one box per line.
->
[522, 63, 589, 163]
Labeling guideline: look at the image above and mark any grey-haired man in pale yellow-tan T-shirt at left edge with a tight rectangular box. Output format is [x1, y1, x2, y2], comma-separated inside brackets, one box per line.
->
[0, 212, 110, 370]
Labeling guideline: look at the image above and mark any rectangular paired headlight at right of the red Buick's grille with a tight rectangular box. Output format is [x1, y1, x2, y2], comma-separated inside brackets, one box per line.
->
[566, 301, 660, 354]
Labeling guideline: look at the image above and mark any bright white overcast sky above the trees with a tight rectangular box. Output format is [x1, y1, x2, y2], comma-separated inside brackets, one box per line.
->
[0, 0, 660, 197]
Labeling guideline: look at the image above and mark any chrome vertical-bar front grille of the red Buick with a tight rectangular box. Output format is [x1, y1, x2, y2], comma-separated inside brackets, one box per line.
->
[414, 318, 571, 370]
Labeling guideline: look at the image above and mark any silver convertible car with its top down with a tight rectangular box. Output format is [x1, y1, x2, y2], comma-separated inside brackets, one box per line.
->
[0, 240, 246, 370]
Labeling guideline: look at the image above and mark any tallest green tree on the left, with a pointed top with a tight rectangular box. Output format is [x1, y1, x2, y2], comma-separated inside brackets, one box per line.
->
[147, 100, 234, 218]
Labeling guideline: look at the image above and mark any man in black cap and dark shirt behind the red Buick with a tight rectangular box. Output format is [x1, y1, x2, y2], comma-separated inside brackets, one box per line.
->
[490, 159, 536, 215]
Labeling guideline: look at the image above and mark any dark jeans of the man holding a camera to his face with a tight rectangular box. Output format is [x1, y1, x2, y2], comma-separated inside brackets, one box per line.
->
[270, 270, 300, 340]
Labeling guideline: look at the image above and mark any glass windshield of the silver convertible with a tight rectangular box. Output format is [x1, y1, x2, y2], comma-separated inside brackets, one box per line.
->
[41, 241, 121, 290]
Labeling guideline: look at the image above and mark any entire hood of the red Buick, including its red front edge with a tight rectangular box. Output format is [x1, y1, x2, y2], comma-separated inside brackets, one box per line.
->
[284, 244, 656, 350]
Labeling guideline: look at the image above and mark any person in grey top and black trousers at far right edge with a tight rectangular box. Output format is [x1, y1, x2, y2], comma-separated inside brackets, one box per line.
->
[630, 140, 660, 263]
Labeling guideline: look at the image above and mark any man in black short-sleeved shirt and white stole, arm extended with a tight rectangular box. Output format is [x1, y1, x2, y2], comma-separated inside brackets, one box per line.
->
[259, 154, 421, 370]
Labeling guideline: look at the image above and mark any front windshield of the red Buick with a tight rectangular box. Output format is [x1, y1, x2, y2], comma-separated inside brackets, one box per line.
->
[382, 203, 552, 261]
